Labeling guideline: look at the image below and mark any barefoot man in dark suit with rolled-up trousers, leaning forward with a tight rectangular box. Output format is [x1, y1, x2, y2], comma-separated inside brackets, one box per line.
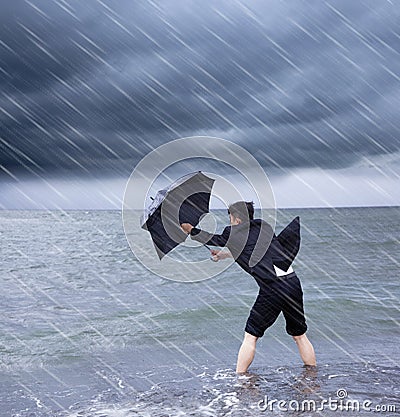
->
[181, 201, 316, 373]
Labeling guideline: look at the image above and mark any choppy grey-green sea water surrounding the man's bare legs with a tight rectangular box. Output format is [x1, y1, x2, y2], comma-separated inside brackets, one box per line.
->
[0, 207, 400, 417]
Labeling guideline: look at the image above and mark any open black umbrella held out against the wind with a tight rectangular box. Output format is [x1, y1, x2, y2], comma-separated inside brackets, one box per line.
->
[141, 171, 215, 260]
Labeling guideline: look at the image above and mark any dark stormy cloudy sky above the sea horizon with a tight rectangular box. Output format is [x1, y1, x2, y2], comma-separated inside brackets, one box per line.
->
[0, 0, 400, 207]
